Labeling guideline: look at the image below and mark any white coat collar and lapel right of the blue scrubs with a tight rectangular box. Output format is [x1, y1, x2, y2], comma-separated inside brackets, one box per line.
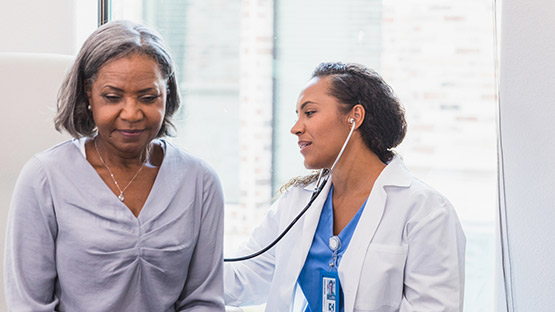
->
[339, 156, 412, 311]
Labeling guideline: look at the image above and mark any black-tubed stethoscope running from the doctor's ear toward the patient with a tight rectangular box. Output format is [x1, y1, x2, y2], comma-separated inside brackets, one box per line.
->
[224, 118, 356, 262]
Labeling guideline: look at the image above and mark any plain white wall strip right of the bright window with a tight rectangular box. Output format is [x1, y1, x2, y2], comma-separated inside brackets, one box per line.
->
[499, 0, 555, 312]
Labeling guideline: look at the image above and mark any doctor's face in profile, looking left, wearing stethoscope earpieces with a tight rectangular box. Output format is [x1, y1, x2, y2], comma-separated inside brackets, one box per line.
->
[291, 77, 349, 169]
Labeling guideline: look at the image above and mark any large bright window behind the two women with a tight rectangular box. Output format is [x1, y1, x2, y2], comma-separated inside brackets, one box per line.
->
[112, 0, 497, 312]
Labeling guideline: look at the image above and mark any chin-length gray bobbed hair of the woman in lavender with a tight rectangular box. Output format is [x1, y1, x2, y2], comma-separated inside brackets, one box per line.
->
[54, 21, 181, 138]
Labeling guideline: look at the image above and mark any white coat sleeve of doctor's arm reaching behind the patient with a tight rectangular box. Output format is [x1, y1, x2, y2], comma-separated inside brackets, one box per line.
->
[224, 194, 287, 306]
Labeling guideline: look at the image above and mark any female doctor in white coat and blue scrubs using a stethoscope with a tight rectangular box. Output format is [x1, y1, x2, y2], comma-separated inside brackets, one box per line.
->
[224, 63, 465, 312]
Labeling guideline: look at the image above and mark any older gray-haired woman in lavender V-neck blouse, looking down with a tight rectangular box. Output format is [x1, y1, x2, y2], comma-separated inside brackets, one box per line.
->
[5, 22, 224, 312]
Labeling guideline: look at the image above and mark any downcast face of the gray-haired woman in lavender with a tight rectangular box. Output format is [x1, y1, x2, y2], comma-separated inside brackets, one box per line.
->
[87, 54, 167, 157]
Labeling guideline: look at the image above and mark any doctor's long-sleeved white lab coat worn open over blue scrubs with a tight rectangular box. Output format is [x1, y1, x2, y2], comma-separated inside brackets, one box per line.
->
[224, 156, 465, 312]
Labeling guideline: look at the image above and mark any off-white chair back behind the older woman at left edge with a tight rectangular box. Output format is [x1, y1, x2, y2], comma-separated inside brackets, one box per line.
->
[0, 53, 74, 311]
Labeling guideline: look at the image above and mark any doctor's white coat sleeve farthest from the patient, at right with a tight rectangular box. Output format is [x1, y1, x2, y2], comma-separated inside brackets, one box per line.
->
[400, 196, 466, 312]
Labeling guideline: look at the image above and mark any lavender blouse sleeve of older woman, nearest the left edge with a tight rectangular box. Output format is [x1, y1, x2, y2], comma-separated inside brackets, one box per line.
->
[4, 157, 58, 311]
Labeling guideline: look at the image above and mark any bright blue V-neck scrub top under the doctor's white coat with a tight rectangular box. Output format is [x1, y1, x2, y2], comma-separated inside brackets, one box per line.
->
[298, 185, 366, 312]
